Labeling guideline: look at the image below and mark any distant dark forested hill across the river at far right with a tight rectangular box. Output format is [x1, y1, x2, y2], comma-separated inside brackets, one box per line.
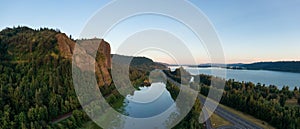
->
[240, 61, 300, 73]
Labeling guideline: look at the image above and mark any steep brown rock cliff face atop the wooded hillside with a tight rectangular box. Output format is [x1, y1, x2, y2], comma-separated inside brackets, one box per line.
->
[56, 34, 112, 86]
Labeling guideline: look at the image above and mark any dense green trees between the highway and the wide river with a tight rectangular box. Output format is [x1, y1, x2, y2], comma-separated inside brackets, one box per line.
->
[199, 75, 300, 129]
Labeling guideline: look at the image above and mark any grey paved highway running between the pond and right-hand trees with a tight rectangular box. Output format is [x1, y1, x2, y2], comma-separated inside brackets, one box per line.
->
[167, 77, 263, 129]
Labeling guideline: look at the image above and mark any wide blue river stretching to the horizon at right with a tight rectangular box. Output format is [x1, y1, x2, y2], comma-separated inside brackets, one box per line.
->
[170, 67, 300, 90]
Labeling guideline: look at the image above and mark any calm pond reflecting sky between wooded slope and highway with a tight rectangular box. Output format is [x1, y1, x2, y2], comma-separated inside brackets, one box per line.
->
[112, 83, 178, 129]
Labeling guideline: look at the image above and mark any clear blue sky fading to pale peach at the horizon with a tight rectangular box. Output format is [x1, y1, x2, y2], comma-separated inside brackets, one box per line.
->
[0, 0, 300, 64]
